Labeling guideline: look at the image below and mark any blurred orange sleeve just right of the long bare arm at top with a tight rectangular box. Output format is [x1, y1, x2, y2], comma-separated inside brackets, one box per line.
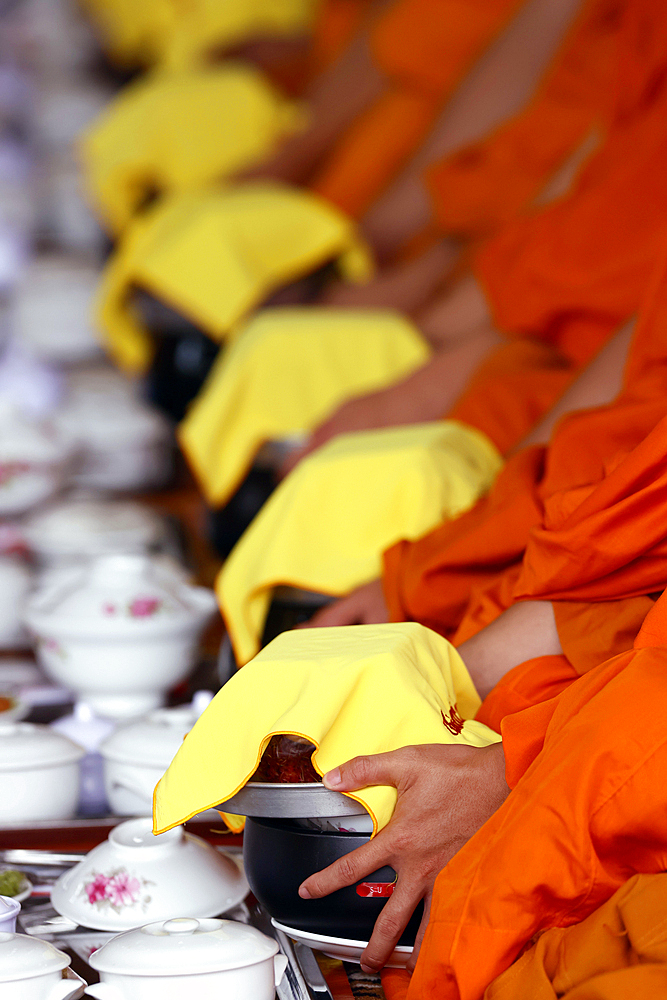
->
[426, 0, 626, 237]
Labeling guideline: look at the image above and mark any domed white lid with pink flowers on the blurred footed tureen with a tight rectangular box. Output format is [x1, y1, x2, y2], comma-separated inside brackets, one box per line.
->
[26, 555, 216, 635]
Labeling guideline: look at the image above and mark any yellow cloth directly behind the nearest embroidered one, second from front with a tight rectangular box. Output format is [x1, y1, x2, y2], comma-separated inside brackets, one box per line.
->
[216, 420, 502, 663]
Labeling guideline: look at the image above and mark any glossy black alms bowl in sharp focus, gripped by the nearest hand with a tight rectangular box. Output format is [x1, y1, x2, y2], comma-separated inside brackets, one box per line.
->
[243, 817, 423, 945]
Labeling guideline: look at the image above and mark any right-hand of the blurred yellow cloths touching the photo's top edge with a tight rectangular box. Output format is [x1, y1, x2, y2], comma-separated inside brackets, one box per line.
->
[161, 0, 320, 68]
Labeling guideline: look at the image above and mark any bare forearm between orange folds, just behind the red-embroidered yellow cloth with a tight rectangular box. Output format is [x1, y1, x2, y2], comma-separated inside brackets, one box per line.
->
[458, 601, 563, 699]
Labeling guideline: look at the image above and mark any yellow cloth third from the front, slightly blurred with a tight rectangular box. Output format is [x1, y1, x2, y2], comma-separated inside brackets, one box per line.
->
[178, 307, 429, 507]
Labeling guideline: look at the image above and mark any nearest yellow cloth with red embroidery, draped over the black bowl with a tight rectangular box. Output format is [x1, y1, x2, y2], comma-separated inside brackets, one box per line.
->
[153, 622, 500, 833]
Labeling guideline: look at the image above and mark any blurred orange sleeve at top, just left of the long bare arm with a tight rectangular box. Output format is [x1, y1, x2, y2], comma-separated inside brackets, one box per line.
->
[312, 0, 521, 216]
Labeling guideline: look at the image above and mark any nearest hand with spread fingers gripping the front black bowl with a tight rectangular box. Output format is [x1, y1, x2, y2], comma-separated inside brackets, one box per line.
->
[299, 743, 509, 972]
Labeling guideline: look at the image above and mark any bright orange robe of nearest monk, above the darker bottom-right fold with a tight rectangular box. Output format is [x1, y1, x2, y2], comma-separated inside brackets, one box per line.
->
[407, 598, 667, 1000]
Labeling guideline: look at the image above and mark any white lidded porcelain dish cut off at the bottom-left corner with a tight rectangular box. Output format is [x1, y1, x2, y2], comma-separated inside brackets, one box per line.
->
[0, 932, 86, 1000]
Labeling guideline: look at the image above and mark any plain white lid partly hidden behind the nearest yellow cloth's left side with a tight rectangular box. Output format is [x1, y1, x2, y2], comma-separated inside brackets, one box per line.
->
[100, 705, 204, 770]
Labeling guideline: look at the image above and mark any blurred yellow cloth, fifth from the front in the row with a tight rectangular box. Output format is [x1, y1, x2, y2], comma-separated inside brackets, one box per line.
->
[79, 63, 305, 233]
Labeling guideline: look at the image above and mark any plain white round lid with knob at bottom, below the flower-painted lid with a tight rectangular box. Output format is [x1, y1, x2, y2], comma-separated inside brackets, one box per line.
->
[89, 917, 278, 976]
